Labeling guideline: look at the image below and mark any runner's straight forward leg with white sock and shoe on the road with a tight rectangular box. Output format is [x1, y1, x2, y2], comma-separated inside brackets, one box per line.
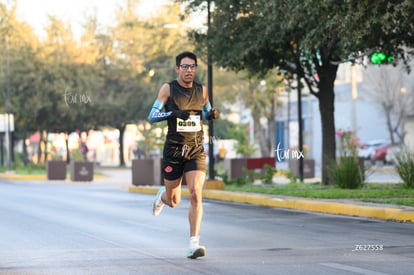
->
[184, 170, 206, 259]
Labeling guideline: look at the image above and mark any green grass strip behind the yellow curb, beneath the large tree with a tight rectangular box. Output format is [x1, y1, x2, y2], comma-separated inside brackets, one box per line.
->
[225, 183, 414, 206]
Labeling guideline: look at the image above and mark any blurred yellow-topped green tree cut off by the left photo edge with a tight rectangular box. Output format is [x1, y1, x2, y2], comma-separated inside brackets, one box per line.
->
[0, 3, 41, 164]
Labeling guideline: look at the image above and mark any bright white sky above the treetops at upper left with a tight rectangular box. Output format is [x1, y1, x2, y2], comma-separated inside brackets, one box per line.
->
[17, 0, 168, 37]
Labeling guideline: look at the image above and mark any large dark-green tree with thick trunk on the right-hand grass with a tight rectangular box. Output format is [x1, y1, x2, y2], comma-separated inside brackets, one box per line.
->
[179, 0, 414, 184]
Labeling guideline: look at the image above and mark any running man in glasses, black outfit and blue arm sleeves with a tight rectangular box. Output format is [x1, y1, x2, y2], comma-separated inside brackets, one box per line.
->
[148, 52, 219, 259]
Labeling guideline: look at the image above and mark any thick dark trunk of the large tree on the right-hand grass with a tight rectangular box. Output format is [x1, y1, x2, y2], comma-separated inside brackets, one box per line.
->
[317, 63, 338, 185]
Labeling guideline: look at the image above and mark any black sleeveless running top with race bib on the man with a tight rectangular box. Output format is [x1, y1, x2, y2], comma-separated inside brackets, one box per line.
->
[165, 80, 204, 146]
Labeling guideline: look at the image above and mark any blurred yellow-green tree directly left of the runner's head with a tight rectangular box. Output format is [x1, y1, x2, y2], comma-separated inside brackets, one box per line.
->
[98, 0, 191, 165]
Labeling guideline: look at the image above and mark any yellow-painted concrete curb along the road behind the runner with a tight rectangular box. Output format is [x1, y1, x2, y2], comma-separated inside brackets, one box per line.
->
[128, 186, 414, 223]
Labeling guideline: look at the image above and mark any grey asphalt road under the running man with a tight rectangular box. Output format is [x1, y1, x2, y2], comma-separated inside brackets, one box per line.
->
[0, 179, 414, 275]
